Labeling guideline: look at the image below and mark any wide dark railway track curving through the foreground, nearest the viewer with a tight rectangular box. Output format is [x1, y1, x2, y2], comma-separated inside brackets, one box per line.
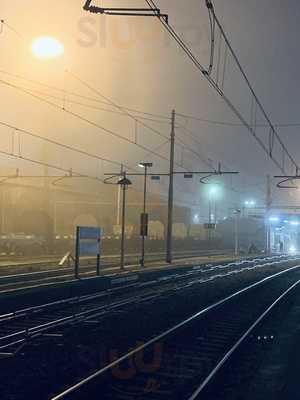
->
[52, 258, 300, 400]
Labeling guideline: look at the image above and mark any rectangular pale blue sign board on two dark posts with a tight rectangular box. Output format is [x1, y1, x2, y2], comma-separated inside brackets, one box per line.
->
[75, 226, 101, 279]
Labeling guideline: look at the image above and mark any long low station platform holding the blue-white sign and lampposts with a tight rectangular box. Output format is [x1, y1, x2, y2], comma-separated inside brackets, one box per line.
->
[0, 255, 260, 313]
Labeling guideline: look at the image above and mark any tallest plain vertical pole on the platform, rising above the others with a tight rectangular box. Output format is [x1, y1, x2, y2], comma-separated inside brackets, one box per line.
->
[166, 110, 176, 264]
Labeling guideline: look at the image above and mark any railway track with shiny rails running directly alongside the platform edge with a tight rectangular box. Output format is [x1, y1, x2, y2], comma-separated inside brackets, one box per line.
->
[0, 256, 291, 357]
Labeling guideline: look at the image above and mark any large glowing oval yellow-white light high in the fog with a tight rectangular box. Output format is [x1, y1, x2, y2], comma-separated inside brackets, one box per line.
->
[31, 36, 64, 60]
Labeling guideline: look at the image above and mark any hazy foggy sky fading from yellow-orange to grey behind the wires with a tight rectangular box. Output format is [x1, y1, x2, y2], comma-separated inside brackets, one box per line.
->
[0, 0, 300, 216]
